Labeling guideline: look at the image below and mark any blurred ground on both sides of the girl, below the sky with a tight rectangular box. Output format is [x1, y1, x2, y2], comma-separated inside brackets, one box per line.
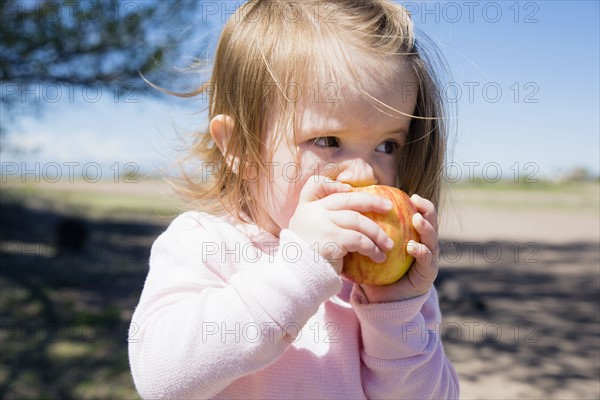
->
[0, 178, 600, 399]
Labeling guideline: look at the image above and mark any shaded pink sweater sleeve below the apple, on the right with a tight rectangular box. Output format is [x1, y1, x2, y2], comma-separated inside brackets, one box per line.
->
[351, 287, 459, 399]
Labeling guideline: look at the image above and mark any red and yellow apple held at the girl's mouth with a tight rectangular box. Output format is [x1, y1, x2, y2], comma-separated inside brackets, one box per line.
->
[342, 185, 419, 285]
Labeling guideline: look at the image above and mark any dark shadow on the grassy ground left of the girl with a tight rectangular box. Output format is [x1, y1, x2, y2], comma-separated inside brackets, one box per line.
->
[0, 198, 167, 399]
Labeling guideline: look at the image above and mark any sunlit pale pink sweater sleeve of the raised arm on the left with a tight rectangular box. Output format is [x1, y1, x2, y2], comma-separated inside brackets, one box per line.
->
[129, 220, 342, 399]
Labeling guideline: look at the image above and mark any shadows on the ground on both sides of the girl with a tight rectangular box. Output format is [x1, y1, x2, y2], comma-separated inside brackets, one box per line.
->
[0, 198, 600, 399]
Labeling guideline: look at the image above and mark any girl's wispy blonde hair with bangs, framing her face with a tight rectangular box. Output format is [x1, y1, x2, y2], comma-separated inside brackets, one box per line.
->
[169, 0, 447, 225]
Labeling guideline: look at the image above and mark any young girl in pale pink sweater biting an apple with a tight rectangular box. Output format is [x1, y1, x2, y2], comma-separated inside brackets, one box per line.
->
[129, 0, 458, 399]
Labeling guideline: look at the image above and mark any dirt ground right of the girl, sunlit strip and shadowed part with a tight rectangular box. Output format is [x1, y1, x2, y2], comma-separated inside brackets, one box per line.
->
[438, 187, 600, 399]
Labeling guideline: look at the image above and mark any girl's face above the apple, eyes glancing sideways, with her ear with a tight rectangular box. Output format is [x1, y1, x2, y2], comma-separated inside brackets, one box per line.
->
[254, 67, 418, 236]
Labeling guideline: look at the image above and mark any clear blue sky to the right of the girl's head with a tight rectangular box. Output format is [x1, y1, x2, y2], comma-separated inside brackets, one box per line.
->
[415, 1, 600, 176]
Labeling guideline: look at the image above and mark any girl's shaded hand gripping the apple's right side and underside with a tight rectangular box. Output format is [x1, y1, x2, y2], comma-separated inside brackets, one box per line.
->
[361, 194, 439, 303]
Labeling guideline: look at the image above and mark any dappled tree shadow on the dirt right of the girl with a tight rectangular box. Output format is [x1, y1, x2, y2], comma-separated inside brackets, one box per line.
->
[437, 241, 600, 399]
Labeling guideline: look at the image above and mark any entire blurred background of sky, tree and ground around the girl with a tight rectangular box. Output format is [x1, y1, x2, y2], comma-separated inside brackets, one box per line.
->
[0, 0, 600, 399]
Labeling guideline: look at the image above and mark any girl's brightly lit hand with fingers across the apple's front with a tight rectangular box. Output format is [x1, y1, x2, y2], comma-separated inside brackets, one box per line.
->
[288, 175, 394, 274]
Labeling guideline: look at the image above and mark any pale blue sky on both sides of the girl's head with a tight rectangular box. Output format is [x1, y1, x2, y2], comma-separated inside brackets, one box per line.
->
[2, 1, 600, 180]
